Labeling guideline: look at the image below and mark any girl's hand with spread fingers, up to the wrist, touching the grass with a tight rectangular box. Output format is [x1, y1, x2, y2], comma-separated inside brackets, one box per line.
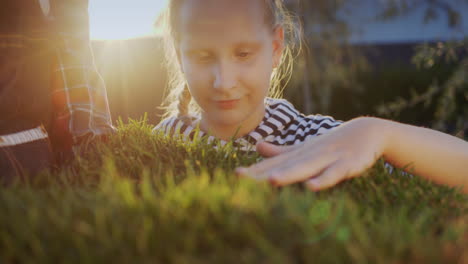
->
[236, 117, 386, 191]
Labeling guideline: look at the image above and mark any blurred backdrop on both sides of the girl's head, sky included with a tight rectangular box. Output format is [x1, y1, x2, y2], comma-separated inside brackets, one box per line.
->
[89, 0, 468, 138]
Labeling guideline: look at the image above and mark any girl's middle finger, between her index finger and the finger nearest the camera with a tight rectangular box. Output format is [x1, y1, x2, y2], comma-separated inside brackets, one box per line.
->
[264, 154, 336, 186]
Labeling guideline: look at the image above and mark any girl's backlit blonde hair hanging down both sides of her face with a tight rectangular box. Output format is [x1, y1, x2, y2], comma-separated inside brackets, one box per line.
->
[159, 0, 302, 122]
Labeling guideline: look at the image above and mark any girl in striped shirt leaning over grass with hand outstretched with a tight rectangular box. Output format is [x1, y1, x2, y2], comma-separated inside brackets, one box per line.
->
[155, 0, 468, 192]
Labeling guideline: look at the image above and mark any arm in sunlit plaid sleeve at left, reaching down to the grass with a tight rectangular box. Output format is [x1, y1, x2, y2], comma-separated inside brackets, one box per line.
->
[51, 0, 114, 159]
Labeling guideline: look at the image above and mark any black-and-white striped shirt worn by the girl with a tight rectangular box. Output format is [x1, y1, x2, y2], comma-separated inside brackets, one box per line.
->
[153, 98, 343, 151]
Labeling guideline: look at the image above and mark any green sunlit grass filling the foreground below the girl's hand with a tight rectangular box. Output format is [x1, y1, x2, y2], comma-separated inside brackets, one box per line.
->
[0, 120, 468, 263]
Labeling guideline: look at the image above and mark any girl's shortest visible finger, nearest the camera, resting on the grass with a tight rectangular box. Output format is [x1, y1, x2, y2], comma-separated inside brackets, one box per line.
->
[305, 162, 351, 191]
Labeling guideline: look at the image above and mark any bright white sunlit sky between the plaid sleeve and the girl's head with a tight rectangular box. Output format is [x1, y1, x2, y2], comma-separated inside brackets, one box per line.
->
[89, 0, 167, 40]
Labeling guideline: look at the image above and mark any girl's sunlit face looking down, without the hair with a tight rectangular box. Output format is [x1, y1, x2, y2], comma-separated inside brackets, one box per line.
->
[177, 0, 283, 137]
